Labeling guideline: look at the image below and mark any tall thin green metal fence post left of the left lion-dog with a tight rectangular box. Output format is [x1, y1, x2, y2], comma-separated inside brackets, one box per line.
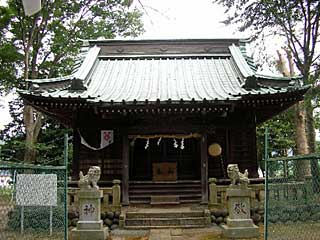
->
[63, 133, 68, 240]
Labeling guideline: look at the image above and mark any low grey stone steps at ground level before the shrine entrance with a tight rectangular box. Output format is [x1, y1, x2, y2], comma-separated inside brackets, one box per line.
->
[121, 207, 210, 229]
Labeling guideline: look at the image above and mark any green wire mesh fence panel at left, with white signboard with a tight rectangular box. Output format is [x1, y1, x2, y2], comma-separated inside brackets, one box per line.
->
[0, 162, 67, 240]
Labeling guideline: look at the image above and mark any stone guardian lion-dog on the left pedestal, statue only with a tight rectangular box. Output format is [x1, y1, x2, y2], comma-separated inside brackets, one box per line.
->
[78, 166, 101, 189]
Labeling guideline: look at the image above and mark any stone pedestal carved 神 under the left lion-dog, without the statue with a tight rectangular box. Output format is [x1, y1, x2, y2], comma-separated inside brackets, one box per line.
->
[71, 188, 108, 240]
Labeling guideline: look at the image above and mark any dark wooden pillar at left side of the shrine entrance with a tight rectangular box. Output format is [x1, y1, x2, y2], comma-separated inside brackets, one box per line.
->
[122, 133, 129, 205]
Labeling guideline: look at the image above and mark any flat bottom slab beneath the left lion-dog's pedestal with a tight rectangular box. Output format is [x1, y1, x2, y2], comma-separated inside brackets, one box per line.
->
[71, 227, 109, 240]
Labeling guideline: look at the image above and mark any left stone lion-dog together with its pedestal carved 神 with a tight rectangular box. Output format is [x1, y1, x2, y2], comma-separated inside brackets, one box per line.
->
[71, 167, 108, 240]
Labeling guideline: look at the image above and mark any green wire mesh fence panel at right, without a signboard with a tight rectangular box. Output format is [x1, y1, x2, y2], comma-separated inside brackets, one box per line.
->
[266, 155, 320, 240]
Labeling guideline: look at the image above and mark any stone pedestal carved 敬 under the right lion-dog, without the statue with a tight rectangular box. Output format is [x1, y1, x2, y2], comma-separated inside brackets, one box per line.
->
[222, 186, 259, 238]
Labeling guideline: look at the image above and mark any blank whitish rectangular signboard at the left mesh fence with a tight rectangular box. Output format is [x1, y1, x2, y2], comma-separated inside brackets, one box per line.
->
[16, 174, 57, 206]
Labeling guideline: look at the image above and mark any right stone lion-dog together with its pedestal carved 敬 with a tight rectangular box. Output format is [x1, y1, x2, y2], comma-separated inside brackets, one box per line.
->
[222, 164, 259, 238]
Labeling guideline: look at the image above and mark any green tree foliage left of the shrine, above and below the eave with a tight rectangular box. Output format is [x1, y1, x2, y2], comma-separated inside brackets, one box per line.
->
[0, 0, 143, 164]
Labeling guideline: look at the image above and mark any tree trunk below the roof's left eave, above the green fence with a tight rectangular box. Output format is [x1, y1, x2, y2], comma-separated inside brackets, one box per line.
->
[23, 105, 42, 163]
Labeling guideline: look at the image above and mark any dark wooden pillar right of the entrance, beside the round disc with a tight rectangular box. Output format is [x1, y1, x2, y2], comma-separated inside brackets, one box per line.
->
[201, 133, 208, 204]
